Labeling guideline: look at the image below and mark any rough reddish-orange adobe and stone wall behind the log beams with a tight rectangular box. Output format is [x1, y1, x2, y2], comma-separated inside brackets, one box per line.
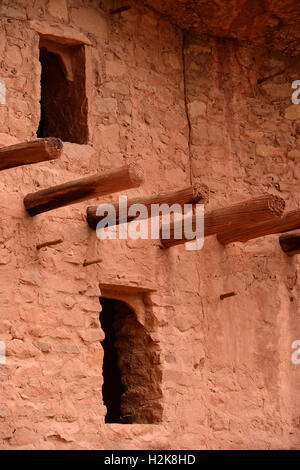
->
[0, 0, 300, 449]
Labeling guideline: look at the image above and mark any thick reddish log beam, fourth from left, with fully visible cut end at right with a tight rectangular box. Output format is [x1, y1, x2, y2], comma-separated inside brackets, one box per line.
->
[161, 194, 285, 248]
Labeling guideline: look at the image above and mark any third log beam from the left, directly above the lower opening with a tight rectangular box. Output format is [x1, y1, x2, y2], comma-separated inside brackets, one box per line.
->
[86, 184, 209, 229]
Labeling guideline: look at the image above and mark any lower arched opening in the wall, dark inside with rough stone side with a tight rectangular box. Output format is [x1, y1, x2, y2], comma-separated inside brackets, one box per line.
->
[100, 298, 162, 424]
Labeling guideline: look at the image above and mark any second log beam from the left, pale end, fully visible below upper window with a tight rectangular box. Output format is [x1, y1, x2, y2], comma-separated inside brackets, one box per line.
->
[24, 164, 144, 215]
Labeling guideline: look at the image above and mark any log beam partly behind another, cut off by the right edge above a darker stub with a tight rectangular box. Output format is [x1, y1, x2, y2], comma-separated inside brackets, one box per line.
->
[217, 210, 300, 245]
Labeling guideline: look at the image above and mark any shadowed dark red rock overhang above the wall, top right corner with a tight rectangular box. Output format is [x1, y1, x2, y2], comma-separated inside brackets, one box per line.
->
[143, 0, 300, 55]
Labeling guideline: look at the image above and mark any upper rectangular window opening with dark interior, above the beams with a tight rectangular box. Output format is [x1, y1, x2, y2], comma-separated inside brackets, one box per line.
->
[37, 38, 88, 144]
